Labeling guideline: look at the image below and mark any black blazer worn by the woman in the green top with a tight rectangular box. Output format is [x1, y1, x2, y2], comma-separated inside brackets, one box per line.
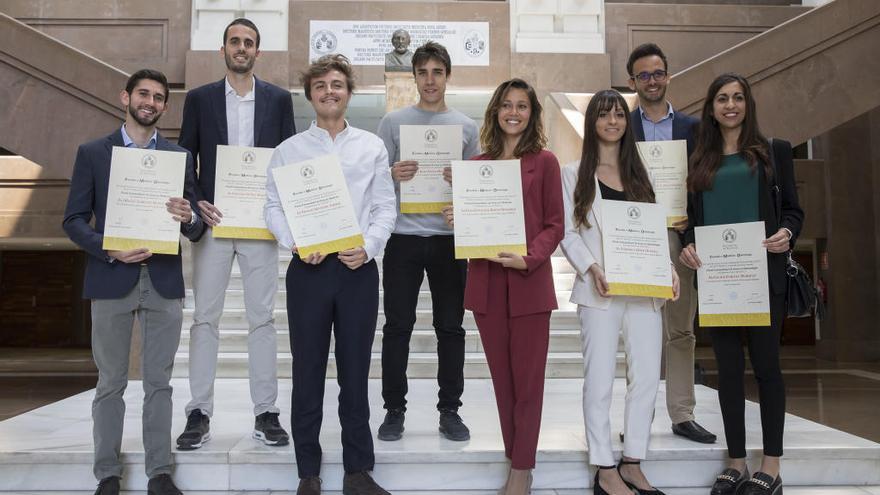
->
[684, 139, 804, 294]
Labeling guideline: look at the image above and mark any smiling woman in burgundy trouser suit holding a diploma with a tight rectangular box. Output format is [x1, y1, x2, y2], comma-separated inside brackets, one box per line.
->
[444, 79, 564, 495]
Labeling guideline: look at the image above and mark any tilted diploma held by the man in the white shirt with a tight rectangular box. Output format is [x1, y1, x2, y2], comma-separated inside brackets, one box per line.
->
[272, 155, 364, 258]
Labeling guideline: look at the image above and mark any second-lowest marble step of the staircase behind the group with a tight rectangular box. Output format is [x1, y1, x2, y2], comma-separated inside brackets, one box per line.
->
[180, 327, 581, 354]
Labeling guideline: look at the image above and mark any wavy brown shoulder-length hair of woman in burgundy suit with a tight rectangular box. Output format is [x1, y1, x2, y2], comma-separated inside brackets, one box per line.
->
[480, 78, 547, 159]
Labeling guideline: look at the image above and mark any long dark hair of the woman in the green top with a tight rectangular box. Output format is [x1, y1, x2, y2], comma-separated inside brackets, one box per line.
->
[687, 73, 773, 192]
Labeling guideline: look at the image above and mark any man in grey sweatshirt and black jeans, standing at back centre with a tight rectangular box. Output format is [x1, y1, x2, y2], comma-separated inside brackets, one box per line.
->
[378, 41, 480, 441]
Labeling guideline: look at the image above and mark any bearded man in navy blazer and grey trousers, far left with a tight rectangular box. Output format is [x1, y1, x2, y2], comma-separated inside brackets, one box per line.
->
[63, 69, 204, 495]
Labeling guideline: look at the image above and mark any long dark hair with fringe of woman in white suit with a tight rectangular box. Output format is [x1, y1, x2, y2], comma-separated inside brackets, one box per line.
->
[574, 89, 655, 228]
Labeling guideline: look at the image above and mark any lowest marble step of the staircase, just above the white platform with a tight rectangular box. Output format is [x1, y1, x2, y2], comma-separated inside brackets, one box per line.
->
[173, 347, 600, 379]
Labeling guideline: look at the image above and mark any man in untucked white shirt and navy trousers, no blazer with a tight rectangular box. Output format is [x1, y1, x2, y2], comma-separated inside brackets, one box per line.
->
[266, 55, 397, 495]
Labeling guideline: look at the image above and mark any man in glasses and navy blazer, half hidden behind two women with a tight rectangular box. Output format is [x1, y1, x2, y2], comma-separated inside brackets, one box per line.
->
[626, 43, 716, 443]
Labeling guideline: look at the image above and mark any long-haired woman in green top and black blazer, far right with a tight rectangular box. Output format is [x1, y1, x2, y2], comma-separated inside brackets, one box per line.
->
[680, 74, 803, 495]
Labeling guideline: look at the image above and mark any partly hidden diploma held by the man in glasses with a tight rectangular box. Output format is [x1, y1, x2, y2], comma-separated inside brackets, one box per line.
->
[637, 139, 687, 227]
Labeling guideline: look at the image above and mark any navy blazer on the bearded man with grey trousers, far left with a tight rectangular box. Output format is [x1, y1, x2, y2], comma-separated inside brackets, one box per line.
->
[62, 130, 205, 299]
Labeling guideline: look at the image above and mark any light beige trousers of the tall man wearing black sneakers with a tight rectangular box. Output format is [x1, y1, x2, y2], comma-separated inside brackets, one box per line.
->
[186, 229, 278, 416]
